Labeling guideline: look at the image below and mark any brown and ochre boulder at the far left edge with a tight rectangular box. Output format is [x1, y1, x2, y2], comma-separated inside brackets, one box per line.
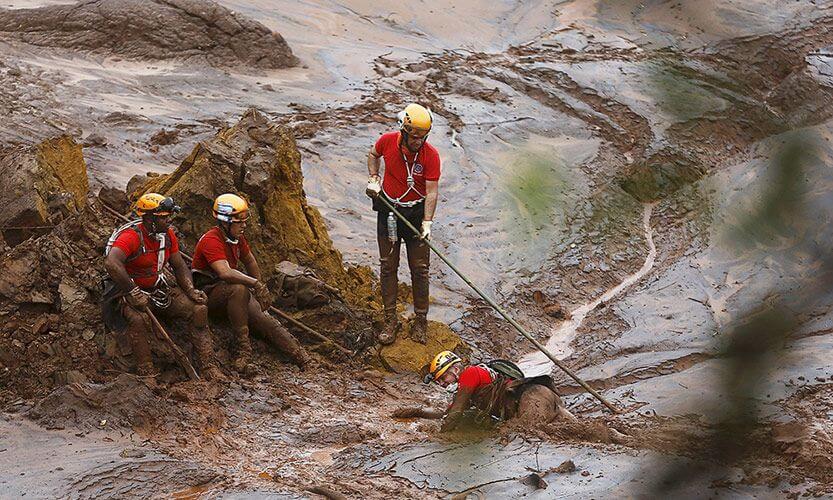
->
[0, 136, 89, 246]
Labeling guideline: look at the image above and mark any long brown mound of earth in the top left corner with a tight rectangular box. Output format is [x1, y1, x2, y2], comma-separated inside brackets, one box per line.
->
[0, 0, 298, 69]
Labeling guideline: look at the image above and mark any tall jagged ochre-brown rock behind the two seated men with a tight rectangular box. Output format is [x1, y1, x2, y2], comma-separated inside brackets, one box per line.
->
[131, 109, 349, 286]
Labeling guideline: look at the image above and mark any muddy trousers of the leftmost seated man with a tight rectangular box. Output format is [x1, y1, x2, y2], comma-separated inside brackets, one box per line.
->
[120, 288, 216, 375]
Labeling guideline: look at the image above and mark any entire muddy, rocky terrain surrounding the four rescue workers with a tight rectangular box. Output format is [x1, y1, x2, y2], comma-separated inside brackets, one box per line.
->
[0, 0, 833, 499]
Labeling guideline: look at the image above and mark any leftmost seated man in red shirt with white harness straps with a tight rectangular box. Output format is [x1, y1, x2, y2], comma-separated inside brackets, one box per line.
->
[102, 193, 223, 380]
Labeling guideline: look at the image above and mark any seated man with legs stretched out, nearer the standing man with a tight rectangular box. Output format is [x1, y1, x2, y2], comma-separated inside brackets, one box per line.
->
[191, 193, 310, 371]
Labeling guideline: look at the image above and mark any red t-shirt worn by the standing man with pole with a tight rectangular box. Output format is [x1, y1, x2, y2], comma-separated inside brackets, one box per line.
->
[375, 132, 440, 202]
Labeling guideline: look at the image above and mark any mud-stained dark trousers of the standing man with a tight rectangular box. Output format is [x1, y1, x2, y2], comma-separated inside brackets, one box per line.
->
[376, 211, 431, 317]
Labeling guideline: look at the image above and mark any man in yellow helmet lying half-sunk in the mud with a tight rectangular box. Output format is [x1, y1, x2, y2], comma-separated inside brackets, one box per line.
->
[393, 351, 577, 432]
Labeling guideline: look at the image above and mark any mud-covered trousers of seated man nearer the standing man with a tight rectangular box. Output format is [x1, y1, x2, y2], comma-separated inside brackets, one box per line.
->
[208, 282, 309, 366]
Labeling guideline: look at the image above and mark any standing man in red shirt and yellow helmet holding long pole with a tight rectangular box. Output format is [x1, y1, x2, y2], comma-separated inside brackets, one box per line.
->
[366, 104, 440, 344]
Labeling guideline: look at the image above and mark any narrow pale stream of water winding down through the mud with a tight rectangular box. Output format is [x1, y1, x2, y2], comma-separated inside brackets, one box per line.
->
[518, 203, 657, 377]
